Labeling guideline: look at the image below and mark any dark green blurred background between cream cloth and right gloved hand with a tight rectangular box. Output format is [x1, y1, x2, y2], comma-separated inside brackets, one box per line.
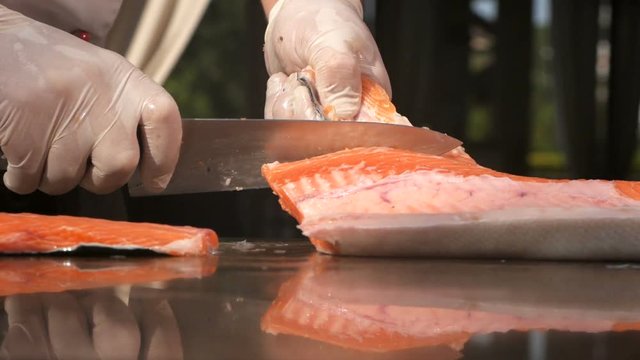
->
[165, 0, 267, 118]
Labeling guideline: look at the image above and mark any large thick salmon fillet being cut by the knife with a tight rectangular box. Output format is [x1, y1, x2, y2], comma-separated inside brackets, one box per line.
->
[262, 71, 640, 260]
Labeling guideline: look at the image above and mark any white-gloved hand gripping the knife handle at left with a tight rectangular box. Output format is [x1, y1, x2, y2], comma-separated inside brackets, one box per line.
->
[0, 6, 182, 194]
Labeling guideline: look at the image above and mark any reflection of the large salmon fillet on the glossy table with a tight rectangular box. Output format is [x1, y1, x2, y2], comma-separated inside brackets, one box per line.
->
[261, 256, 640, 352]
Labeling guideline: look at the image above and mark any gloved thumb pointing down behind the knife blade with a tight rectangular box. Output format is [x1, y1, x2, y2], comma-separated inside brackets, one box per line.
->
[310, 48, 362, 120]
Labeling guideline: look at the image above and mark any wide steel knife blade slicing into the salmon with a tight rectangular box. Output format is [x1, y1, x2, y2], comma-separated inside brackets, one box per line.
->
[4, 119, 462, 196]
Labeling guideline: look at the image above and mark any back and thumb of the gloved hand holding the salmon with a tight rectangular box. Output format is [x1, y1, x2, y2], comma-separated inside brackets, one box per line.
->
[264, 0, 391, 120]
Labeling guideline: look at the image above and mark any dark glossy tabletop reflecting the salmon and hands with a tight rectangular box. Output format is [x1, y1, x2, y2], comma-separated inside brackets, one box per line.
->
[0, 240, 640, 359]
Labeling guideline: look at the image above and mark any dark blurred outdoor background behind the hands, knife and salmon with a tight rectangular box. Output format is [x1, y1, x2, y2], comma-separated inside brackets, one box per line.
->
[130, 0, 640, 236]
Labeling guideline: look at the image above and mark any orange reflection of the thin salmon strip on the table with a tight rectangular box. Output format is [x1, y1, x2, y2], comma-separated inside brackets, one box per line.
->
[0, 256, 218, 296]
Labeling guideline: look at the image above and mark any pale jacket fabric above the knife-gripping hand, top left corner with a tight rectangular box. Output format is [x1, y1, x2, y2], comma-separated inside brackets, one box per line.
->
[0, 0, 122, 46]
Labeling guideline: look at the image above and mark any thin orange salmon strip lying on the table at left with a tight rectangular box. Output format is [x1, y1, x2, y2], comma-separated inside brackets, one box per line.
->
[0, 213, 218, 256]
